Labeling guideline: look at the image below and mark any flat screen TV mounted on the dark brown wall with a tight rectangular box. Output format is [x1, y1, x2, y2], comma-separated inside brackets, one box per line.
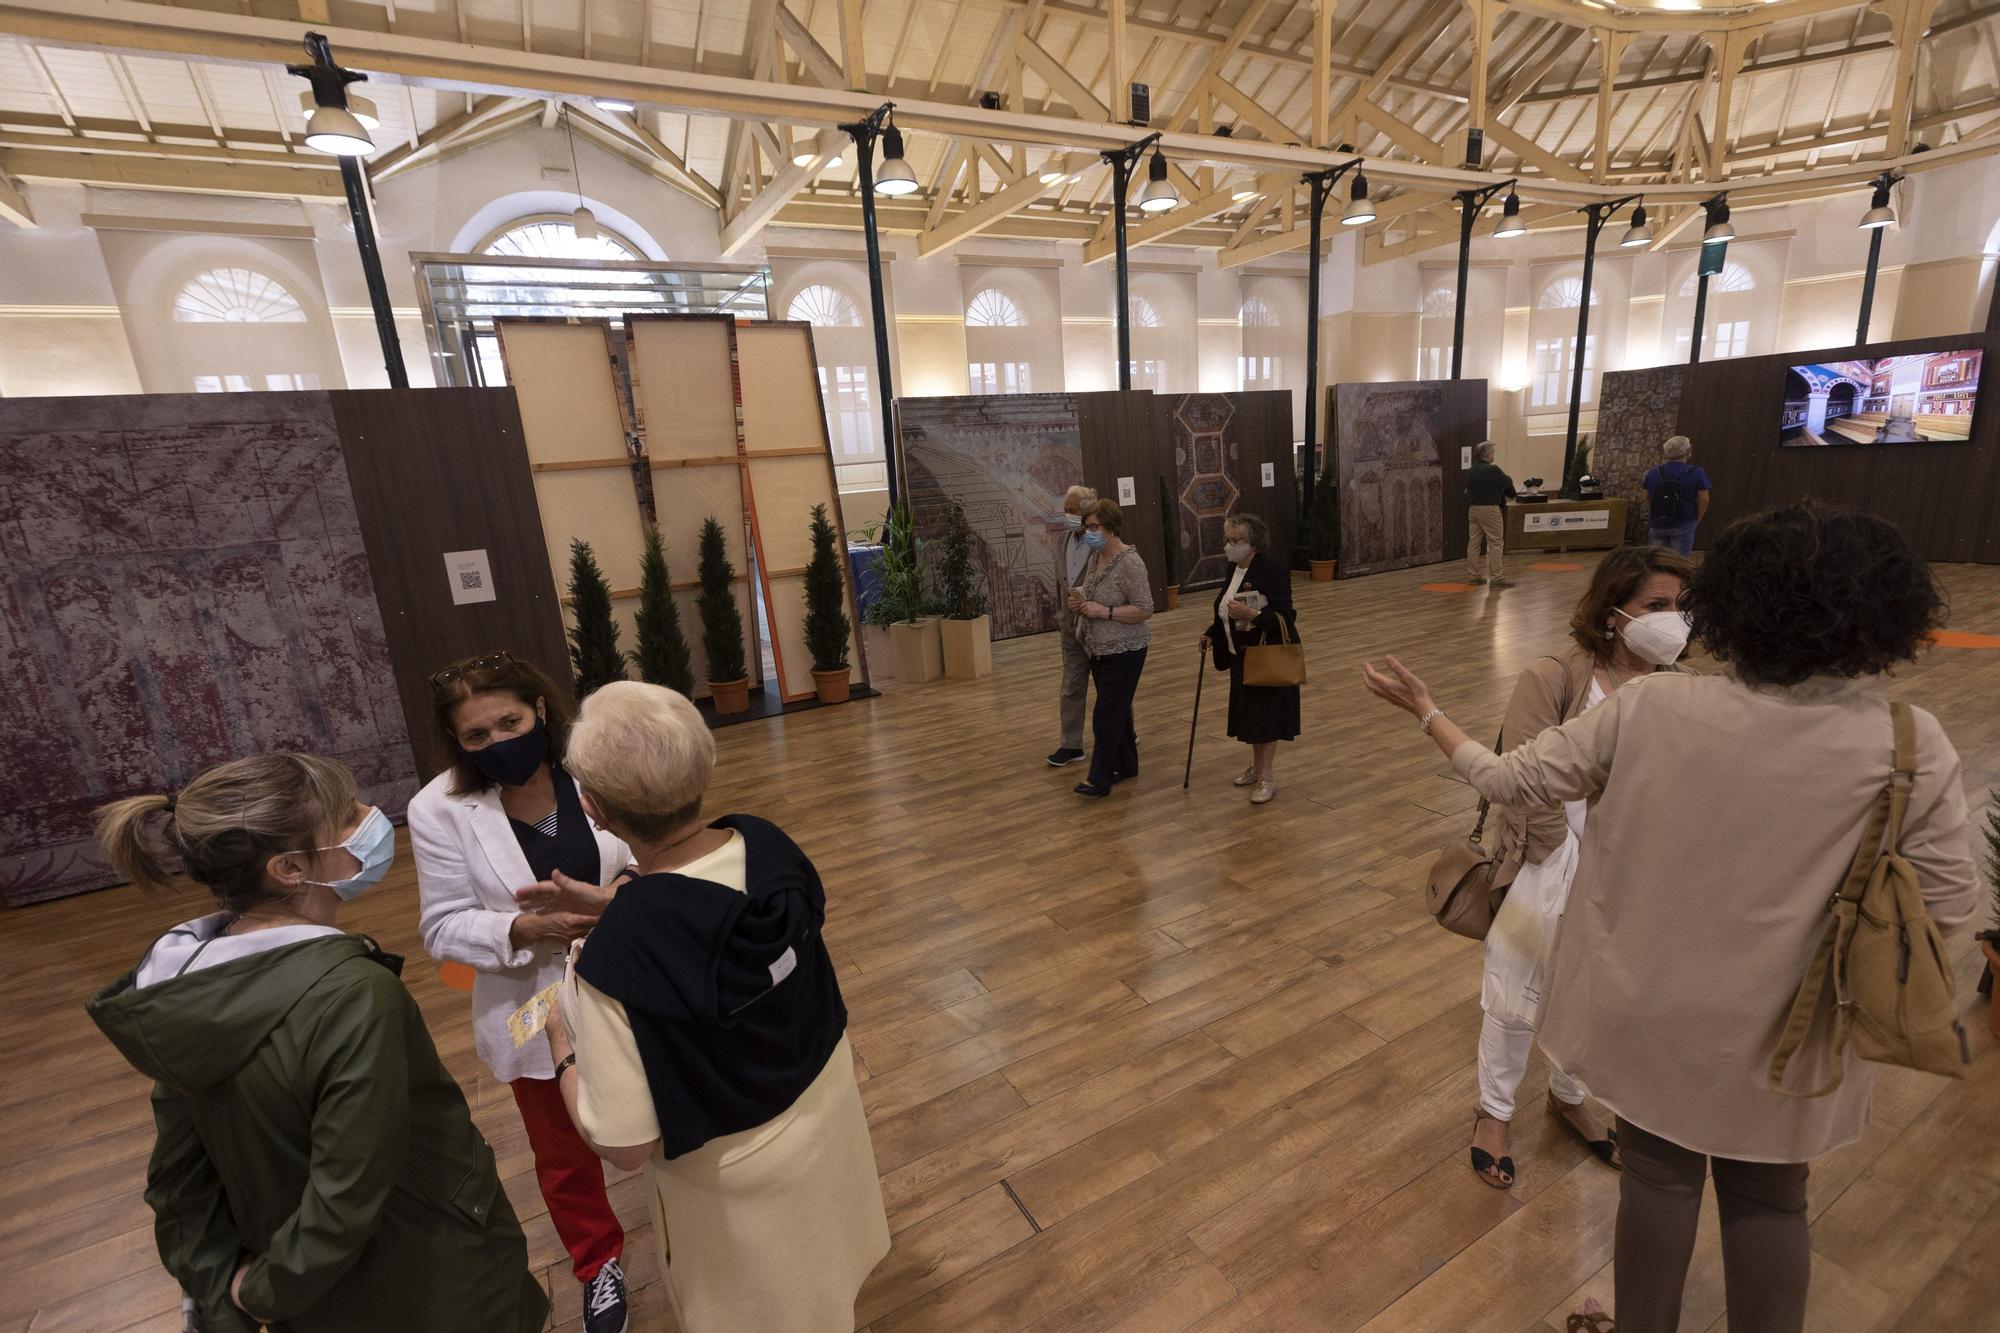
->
[1778, 348, 1982, 446]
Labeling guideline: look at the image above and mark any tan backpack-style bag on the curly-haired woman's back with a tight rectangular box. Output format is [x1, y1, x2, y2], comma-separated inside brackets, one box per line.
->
[1768, 703, 1972, 1097]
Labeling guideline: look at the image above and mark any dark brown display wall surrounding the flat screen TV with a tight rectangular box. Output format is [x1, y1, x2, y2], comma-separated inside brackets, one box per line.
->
[1678, 332, 2000, 564]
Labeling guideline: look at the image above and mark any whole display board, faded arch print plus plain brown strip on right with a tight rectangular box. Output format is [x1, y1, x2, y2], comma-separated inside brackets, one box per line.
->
[1326, 380, 1486, 578]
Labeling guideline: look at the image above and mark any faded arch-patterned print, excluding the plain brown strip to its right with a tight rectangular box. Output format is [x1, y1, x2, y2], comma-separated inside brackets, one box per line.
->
[1334, 382, 1446, 578]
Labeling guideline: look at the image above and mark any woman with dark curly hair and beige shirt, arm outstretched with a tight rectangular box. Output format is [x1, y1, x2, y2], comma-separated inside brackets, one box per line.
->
[1364, 506, 1978, 1333]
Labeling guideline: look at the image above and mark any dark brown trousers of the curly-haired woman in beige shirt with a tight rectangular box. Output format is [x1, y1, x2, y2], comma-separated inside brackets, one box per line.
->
[1612, 1119, 1812, 1333]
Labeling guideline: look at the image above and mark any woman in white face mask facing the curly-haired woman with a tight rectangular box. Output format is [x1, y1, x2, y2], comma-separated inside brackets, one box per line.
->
[1472, 546, 1694, 1189]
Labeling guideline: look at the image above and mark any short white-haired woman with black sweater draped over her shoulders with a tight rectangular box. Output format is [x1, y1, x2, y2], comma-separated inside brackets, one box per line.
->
[548, 681, 888, 1333]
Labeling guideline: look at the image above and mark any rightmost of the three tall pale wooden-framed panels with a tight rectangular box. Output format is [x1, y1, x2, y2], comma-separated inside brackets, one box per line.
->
[734, 322, 866, 703]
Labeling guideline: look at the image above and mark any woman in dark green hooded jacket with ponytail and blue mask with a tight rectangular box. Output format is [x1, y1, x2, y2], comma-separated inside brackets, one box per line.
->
[88, 755, 548, 1333]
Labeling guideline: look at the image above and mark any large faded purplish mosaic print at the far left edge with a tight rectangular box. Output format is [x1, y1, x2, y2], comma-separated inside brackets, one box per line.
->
[0, 394, 418, 905]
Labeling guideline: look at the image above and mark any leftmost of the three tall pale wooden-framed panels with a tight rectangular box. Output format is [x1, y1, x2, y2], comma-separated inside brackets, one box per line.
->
[494, 318, 646, 650]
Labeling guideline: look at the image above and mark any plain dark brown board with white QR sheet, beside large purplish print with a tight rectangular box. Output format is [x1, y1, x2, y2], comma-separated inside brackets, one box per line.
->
[334, 388, 570, 772]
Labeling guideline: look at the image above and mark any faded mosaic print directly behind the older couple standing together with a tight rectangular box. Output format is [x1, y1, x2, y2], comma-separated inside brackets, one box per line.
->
[896, 394, 1084, 638]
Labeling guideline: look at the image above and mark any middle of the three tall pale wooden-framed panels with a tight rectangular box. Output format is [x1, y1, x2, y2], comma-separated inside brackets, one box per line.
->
[626, 314, 762, 699]
